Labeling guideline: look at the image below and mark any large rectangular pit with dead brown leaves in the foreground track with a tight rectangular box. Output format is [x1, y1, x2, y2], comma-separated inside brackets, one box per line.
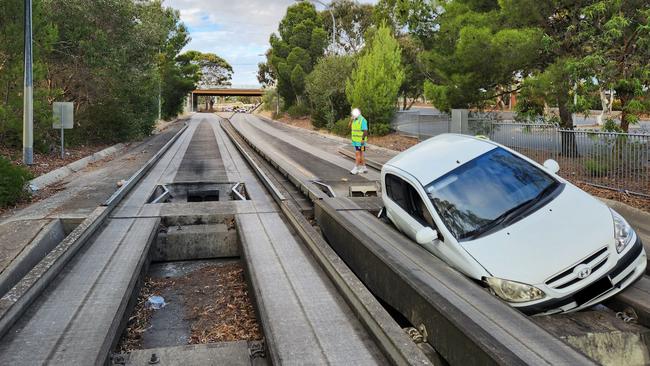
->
[114, 215, 263, 365]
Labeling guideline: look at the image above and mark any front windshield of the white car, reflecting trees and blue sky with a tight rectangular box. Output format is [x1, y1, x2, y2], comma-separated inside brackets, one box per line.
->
[425, 148, 559, 240]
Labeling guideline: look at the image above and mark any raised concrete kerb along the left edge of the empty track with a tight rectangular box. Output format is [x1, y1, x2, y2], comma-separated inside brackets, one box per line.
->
[0, 124, 187, 338]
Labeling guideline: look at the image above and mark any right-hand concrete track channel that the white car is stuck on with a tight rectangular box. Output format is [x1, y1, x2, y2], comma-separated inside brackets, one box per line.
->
[224, 114, 650, 365]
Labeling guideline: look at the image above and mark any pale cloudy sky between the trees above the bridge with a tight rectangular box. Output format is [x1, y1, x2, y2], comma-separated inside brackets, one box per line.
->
[165, 0, 375, 85]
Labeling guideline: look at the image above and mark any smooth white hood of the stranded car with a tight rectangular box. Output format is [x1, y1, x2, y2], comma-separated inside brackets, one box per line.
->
[461, 184, 614, 285]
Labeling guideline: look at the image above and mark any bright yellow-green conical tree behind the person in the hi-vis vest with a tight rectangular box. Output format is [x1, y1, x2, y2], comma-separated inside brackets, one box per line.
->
[345, 26, 404, 129]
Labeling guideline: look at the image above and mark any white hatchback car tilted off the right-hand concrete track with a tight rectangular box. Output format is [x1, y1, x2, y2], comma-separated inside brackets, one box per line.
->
[381, 134, 646, 314]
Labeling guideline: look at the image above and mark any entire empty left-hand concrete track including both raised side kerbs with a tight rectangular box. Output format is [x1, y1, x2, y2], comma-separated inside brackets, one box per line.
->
[0, 114, 420, 365]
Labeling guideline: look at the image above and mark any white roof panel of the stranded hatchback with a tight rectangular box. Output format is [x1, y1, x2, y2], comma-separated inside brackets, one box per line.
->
[386, 133, 500, 185]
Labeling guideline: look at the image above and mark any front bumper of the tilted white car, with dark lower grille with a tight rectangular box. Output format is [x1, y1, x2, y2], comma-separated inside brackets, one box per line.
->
[513, 236, 647, 315]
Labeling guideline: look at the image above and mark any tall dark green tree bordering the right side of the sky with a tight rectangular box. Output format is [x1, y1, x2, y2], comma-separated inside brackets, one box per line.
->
[260, 1, 327, 107]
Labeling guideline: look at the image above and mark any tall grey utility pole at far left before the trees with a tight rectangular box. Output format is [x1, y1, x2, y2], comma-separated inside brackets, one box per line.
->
[23, 0, 34, 165]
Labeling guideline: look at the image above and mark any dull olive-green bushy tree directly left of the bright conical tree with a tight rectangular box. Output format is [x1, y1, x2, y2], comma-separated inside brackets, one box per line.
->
[306, 55, 354, 129]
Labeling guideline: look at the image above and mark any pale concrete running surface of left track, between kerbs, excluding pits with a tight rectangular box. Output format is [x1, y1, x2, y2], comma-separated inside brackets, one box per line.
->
[0, 114, 386, 365]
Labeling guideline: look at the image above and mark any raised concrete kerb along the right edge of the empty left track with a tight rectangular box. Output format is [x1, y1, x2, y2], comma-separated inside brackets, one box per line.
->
[222, 118, 431, 365]
